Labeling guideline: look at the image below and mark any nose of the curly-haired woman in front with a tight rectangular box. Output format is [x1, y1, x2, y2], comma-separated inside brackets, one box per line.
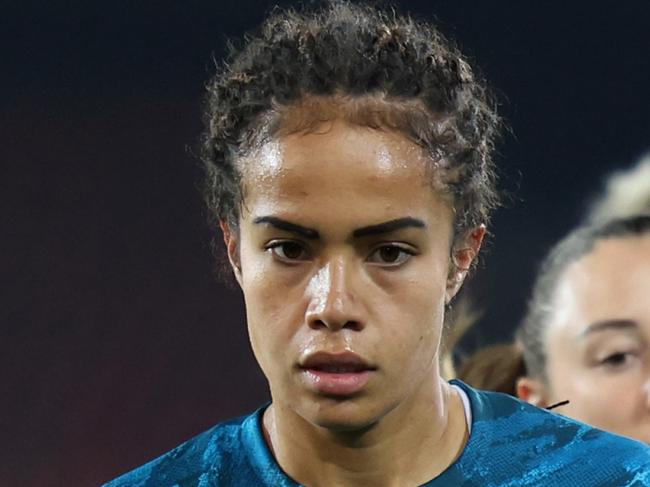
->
[305, 258, 364, 331]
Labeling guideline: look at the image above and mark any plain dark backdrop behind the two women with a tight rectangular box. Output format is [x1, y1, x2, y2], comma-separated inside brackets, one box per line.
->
[0, 0, 650, 486]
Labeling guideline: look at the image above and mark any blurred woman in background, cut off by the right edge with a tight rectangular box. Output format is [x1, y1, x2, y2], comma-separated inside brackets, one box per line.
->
[457, 157, 650, 443]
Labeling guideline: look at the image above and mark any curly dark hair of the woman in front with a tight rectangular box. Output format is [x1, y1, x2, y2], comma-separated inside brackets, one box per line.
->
[202, 0, 500, 240]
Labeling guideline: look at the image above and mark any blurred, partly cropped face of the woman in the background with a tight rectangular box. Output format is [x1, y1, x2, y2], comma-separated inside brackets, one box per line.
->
[546, 236, 650, 443]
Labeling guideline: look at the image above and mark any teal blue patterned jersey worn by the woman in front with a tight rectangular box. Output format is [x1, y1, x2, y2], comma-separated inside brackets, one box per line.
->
[105, 381, 650, 487]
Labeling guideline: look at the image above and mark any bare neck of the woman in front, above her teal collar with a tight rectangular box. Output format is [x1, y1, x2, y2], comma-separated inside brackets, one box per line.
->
[264, 375, 467, 487]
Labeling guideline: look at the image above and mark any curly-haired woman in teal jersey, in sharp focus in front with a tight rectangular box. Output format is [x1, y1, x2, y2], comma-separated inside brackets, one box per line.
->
[108, 1, 650, 487]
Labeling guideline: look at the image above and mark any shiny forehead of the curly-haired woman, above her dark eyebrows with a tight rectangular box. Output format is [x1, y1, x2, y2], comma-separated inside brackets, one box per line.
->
[241, 120, 451, 231]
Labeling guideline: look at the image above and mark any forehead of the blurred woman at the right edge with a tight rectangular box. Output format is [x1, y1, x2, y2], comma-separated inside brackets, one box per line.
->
[555, 235, 650, 328]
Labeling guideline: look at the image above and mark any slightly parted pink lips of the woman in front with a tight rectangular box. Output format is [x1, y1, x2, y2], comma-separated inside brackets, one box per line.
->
[300, 352, 377, 397]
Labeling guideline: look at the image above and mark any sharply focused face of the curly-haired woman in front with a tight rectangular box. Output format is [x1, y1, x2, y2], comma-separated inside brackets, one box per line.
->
[226, 121, 480, 429]
